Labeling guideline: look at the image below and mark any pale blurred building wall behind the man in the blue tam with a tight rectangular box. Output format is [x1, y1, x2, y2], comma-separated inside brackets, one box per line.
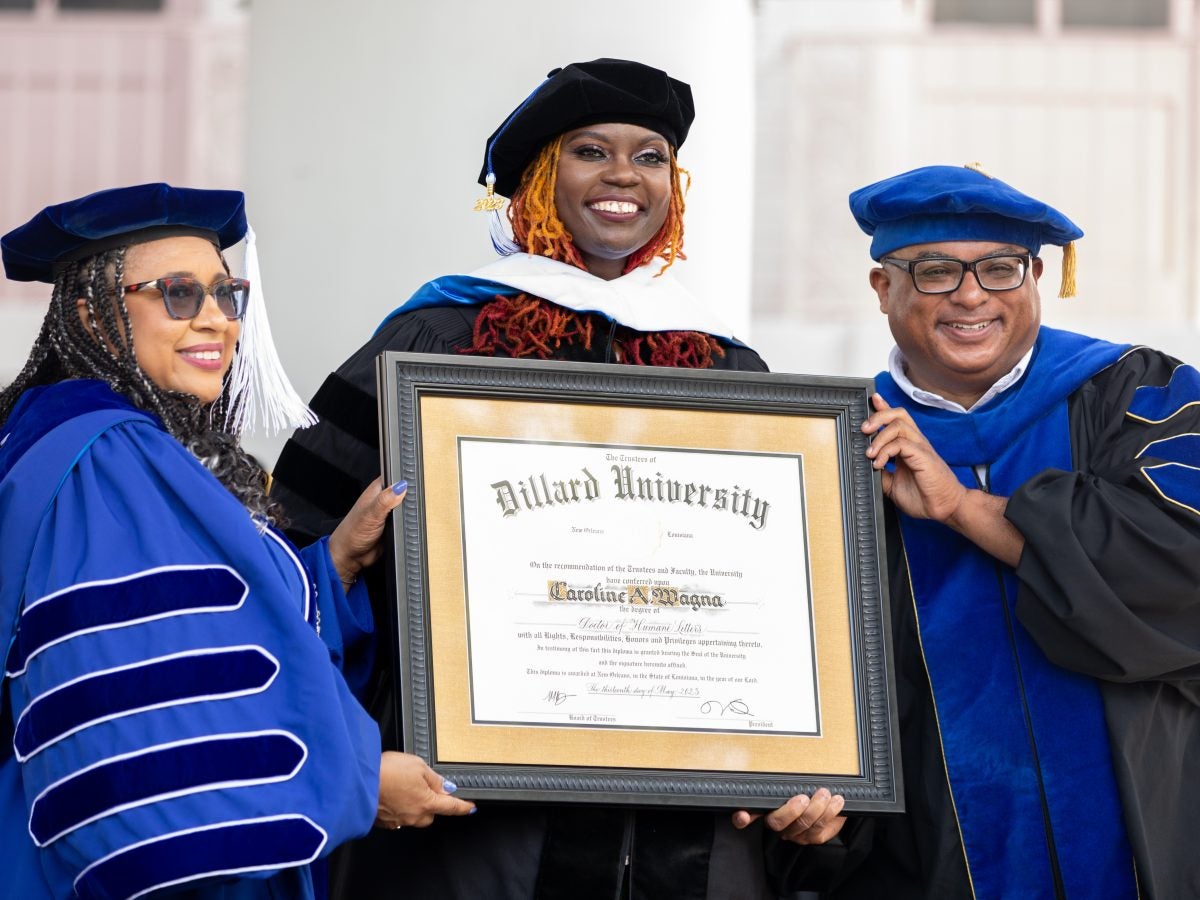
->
[751, 0, 1200, 381]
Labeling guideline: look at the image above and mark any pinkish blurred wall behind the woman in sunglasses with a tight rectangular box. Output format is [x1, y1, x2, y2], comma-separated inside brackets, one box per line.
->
[0, 0, 248, 312]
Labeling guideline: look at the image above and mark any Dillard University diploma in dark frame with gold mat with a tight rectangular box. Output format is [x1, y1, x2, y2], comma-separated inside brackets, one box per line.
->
[379, 353, 904, 811]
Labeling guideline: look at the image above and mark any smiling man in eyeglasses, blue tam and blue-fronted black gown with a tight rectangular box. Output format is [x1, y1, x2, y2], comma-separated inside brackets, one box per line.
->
[763, 167, 1200, 900]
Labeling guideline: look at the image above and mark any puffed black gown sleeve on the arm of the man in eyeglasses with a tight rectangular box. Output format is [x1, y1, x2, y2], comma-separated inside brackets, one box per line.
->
[1007, 348, 1200, 686]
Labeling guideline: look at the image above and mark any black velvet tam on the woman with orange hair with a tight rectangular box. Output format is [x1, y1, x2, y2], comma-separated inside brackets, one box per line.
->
[479, 59, 696, 197]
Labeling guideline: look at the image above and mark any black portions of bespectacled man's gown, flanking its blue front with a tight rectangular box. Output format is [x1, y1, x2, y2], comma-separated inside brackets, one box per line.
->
[785, 340, 1200, 900]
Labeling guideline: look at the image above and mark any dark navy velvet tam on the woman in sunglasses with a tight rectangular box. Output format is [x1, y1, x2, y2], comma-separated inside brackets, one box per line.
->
[0, 184, 246, 283]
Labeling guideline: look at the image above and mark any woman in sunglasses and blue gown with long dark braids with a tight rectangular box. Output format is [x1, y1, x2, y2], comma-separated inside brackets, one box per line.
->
[0, 185, 473, 900]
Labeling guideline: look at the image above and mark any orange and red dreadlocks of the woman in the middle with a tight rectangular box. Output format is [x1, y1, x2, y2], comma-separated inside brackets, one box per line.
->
[463, 136, 725, 368]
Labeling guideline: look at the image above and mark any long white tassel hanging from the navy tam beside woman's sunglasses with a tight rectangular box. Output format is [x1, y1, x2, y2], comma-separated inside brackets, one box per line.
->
[229, 224, 317, 436]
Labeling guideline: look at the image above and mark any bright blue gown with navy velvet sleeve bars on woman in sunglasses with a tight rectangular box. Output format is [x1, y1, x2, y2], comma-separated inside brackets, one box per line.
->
[0, 380, 380, 900]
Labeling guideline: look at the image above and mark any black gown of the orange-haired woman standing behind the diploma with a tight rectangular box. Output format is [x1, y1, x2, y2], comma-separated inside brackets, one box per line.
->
[272, 306, 806, 900]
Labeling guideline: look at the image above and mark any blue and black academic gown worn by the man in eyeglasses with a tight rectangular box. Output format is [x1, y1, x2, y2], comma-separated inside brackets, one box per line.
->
[790, 328, 1200, 900]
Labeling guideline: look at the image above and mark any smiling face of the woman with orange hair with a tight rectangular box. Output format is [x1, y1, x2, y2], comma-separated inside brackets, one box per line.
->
[554, 122, 671, 281]
